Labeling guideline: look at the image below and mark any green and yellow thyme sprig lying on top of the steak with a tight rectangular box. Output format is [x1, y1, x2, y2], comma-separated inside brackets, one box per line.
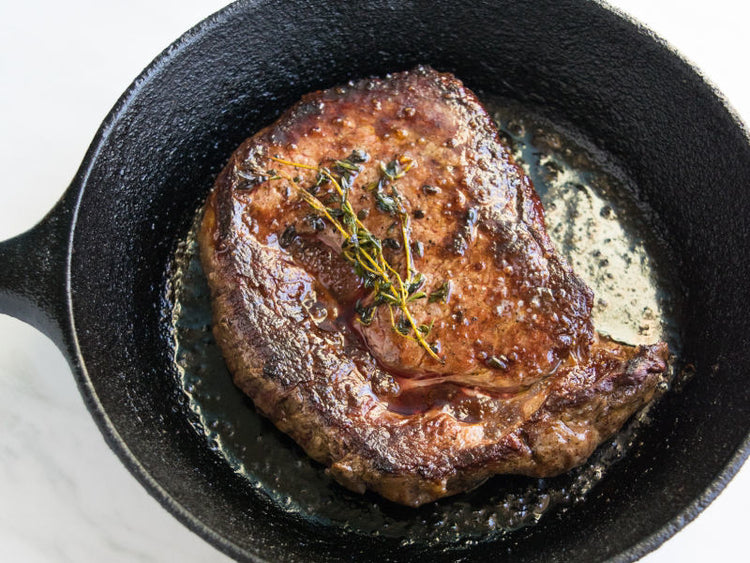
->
[266, 150, 443, 361]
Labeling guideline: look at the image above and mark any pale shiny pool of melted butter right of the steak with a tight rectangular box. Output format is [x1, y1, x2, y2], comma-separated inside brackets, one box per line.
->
[493, 103, 676, 345]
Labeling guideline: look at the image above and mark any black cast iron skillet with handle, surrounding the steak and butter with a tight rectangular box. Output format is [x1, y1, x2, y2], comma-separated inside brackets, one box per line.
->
[0, 0, 750, 562]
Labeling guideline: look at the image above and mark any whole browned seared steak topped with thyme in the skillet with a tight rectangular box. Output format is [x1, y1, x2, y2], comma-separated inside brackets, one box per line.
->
[200, 67, 668, 506]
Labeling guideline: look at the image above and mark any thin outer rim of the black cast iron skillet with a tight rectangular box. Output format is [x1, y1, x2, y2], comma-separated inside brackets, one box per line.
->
[58, 0, 750, 563]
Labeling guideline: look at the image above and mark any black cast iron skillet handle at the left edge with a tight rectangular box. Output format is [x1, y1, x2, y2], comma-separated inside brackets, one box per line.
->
[0, 187, 78, 346]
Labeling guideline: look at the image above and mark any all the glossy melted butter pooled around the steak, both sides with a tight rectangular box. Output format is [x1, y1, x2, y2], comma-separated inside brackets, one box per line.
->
[167, 97, 678, 546]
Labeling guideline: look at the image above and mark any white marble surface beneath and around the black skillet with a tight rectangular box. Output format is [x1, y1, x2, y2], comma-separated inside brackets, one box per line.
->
[0, 0, 750, 563]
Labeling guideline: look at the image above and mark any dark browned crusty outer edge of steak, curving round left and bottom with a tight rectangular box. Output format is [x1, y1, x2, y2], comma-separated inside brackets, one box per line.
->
[199, 69, 668, 506]
